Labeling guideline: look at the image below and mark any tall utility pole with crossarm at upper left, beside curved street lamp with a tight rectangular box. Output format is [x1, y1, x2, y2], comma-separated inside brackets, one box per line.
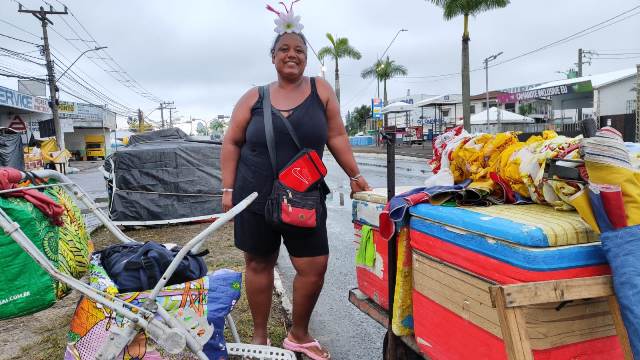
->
[18, 4, 68, 150]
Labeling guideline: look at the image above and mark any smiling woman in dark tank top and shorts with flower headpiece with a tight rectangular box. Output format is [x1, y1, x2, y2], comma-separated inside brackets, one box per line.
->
[222, 29, 370, 359]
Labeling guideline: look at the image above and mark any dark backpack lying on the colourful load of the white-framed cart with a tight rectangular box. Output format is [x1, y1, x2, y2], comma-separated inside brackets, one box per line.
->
[99, 241, 209, 293]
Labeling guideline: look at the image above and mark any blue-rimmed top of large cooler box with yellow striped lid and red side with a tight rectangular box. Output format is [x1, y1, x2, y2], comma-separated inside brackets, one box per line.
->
[410, 204, 610, 284]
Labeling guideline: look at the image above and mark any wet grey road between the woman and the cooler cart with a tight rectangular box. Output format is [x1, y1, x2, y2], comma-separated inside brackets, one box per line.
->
[278, 154, 427, 360]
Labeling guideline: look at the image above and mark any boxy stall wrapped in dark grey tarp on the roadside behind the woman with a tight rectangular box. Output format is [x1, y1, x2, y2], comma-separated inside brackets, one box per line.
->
[104, 128, 222, 225]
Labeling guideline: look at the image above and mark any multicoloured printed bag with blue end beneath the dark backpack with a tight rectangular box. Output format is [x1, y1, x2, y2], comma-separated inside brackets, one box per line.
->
[64, 254, 242, 360]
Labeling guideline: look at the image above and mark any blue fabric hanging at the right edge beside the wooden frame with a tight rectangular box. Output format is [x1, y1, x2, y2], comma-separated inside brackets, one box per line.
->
[600, 225, 640, 359]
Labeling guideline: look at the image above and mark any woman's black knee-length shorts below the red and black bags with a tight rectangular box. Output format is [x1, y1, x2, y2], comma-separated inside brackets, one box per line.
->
[233, 204, 329, 257]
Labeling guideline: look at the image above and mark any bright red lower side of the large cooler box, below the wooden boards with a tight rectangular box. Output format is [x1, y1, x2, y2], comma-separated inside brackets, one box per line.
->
[413, 291, 623, 360]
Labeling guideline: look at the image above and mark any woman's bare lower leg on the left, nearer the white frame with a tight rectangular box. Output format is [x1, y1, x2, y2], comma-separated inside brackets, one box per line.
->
[244, 251, 278, 345]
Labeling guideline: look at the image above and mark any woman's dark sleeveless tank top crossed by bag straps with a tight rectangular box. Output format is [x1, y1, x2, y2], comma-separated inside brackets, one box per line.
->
[233, 78, 328, 213]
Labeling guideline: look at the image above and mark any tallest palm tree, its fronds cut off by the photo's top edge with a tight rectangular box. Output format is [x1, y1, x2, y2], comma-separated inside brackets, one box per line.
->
[431, 0, 509, 131]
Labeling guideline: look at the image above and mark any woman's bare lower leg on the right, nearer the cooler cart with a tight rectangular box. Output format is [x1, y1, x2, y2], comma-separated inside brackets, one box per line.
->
[289, 255, 329, 344]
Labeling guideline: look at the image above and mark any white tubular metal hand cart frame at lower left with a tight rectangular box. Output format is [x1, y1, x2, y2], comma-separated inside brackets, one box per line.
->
[0, 169, 295, 360]
